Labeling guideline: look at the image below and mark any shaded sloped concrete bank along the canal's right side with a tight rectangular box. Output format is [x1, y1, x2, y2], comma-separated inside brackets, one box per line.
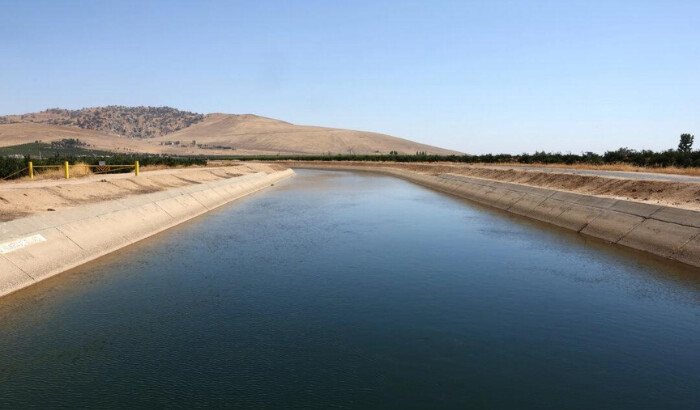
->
[296, 163, 700, 267]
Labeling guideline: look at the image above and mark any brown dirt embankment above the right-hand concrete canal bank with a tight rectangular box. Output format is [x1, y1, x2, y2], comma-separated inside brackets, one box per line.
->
[285, 161, 700, 211]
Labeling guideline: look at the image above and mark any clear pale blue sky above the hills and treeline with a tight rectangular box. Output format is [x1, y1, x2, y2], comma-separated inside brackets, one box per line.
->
[0, 0, 700, 154]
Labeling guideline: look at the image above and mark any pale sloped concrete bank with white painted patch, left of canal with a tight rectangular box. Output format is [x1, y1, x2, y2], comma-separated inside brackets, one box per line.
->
[0, 169, 294, 296]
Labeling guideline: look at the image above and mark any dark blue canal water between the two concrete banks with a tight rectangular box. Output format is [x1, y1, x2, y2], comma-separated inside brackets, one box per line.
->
[0, 170, 700, 409]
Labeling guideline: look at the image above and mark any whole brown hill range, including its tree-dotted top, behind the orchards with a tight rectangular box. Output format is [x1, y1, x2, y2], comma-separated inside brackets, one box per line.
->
[0, 106, 459, 155]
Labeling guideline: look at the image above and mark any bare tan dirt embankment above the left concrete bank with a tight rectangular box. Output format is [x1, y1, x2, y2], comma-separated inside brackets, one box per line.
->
[0, 163, 286, 222]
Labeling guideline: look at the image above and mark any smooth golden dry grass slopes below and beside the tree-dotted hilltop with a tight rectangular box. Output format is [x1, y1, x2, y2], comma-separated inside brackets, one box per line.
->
[0, 114, 460, 155]
